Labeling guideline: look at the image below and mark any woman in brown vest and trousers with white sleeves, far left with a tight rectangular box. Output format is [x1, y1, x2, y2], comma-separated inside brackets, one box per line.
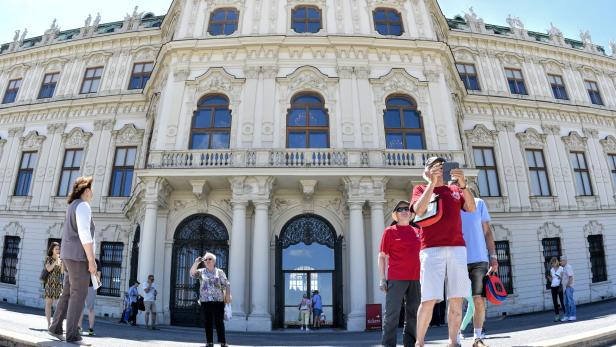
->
[49, 176, 97, 345]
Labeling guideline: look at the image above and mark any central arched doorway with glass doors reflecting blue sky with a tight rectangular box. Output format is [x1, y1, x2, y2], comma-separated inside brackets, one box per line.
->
[274, 214, 343, 328]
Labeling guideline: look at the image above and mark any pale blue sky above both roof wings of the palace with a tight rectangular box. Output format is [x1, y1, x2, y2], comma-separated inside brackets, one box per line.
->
[0, 0, 616, 51]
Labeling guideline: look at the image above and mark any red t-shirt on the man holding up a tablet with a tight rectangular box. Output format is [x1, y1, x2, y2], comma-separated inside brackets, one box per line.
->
[411, 184, 466, 249]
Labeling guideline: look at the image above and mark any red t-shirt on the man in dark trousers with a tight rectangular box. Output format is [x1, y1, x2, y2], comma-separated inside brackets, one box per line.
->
[380, 225, 420, 281]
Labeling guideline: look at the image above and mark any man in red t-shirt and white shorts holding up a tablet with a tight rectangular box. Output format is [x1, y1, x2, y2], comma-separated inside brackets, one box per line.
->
[411, 157, 476, 346]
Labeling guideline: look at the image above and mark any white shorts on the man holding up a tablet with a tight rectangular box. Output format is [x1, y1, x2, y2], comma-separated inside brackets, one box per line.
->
[419, 246, 471, 302]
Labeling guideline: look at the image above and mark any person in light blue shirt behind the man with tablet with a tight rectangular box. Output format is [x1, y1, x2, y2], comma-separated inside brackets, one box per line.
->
[456, 196, 498, 347]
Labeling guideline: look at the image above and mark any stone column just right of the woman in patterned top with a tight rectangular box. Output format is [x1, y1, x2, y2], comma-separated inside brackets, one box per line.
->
[227, 200, 248, 331]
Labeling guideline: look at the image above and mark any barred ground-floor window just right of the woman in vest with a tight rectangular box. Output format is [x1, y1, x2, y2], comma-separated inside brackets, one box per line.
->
[98, 242, 124, 297]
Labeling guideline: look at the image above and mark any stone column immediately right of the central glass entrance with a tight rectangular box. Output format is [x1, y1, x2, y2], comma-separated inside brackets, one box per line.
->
[347, 200, 366, 331]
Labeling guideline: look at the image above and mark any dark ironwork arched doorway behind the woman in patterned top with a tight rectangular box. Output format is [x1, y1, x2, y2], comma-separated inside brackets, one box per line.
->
[169, 214, 229, 326]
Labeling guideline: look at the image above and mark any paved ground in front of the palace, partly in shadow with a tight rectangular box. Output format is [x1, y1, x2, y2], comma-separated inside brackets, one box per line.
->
[0, 300, 616, 347]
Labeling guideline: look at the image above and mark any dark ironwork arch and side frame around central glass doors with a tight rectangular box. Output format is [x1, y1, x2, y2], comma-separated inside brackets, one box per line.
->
[273, 213, 345, 329]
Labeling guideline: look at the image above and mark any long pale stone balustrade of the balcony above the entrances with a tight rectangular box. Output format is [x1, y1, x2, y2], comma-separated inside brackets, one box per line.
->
[148, 149, 463, 169]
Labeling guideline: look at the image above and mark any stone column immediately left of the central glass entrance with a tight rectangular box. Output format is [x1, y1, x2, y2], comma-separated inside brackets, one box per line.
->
[248, 200, 272, 331]
